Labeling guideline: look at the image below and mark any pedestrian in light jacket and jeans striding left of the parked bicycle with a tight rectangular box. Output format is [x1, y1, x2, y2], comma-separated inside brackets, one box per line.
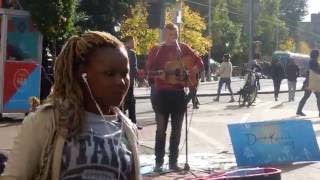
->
[214, 54, 234, 102]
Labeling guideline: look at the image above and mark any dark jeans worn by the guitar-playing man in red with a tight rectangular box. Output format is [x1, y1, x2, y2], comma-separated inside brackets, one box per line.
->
[151, 88, 186, 165]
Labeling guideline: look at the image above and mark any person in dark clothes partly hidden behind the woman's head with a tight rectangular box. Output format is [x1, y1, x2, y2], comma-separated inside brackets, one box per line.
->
[123, 36, 142, 129]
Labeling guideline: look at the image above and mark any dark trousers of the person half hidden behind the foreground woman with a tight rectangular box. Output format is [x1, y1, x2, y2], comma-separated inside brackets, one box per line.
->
[125, 86, 137, 124]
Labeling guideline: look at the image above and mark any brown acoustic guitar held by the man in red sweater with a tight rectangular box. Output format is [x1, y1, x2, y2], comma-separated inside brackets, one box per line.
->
[148, 56, 200, 87]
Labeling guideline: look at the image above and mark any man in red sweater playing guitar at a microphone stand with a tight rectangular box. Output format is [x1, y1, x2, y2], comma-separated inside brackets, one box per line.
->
[146, 23, 203, 172]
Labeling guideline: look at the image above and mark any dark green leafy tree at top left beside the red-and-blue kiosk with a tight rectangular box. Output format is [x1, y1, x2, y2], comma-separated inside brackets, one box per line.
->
[21, 0, 76, 55]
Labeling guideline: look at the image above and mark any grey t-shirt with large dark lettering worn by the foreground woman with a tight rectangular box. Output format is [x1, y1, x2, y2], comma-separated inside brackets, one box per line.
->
[61, 112, 133, 180]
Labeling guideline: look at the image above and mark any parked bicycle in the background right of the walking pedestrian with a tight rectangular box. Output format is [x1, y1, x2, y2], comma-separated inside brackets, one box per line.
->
[239, 70, 261, 107]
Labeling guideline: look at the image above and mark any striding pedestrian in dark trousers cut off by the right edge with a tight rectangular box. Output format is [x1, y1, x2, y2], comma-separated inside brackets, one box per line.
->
[297, 50, 320, 117]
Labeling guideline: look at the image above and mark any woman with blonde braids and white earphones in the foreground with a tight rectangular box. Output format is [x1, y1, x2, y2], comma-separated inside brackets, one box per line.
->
[3, 31, 140, 180]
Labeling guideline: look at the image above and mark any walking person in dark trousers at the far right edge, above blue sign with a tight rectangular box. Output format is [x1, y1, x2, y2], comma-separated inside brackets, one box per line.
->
[296, 50, 320, 117]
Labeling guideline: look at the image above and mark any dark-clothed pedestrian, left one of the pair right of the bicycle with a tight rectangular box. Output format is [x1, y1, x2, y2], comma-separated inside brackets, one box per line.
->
[270, 59, 284, 101]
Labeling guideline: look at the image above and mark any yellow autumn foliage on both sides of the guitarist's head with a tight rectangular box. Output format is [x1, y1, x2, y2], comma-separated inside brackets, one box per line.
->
[120, 2, 211, 55]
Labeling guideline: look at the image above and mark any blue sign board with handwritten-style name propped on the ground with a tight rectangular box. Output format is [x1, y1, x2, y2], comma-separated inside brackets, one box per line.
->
[228, 120, 320, 167]
